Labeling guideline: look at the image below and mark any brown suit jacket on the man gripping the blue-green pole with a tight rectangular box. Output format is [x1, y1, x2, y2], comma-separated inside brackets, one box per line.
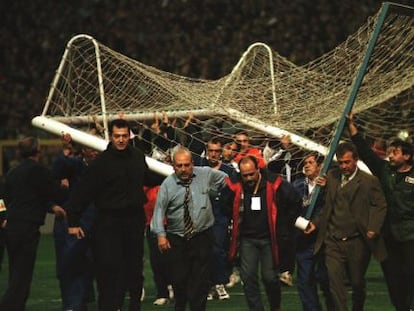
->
[313, 168, 387, 261]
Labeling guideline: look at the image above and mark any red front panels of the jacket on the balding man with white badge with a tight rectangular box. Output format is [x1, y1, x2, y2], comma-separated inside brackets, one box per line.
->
[226, 176, 282, 265]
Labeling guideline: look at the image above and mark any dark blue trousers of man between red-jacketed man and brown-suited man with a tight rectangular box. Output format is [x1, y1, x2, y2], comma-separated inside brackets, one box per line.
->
[296, 243, 334, 311]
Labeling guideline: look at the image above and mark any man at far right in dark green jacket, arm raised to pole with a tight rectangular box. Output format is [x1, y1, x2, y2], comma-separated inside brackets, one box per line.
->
[348, 114, 414, 311]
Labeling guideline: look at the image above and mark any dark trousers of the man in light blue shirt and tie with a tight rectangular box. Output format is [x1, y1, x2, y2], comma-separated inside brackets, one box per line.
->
[165, 229, 214, 311]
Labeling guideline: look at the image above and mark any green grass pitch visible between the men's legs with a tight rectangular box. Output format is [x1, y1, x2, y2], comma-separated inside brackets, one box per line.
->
[0, 234, 393, 311]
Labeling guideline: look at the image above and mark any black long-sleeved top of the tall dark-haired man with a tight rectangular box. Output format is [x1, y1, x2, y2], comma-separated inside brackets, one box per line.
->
[68, 144, 149, 227]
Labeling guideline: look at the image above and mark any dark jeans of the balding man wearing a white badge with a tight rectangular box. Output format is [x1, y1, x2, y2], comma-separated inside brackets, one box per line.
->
[240, 237, 281, 311]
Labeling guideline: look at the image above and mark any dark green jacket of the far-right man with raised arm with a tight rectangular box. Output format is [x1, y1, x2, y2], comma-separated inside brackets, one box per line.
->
[352, 134, 414, 241]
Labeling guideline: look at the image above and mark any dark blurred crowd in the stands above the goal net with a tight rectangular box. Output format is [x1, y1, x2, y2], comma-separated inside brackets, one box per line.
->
[0, 0, 410, 139]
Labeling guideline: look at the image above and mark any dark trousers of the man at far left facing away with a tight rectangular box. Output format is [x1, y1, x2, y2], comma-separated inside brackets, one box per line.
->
[0, 223, 40, 311]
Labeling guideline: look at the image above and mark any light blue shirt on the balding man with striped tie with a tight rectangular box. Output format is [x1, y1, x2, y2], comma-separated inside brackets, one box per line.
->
[151, 167, 227, 236]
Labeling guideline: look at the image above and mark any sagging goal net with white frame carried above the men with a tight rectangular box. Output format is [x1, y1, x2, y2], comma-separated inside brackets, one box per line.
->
[33, 1, 414, 178]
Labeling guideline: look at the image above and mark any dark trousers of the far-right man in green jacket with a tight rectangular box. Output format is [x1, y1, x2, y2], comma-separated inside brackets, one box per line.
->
[381, 237, 414, 311]
